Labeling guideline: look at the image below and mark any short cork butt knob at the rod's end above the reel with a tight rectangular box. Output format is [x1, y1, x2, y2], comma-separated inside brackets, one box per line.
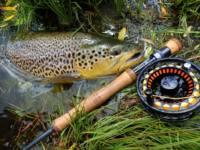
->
[165, 38, 182, 54]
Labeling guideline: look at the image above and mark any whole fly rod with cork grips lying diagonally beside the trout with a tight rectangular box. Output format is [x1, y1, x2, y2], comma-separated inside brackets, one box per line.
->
[22, 38, 182, 150]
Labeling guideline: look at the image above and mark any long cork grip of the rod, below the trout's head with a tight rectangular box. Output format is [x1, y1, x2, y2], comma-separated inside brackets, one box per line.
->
[53, 69, 137, 132]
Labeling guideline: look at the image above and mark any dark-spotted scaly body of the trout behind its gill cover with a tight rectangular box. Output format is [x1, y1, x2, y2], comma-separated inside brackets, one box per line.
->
[6, 33, 84, 77]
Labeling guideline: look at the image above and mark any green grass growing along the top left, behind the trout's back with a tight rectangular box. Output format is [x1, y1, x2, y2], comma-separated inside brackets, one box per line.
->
[0, 0, 124, 31]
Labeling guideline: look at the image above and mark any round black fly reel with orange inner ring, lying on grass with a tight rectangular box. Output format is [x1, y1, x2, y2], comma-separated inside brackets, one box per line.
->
[136, 58, 200, 121]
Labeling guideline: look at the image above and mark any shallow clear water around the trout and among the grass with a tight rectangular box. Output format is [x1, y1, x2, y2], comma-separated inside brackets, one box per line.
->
[0, 1, 174, 149]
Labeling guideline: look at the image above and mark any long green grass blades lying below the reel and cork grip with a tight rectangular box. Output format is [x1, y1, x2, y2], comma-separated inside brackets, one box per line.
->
[57, 100, 200, 149]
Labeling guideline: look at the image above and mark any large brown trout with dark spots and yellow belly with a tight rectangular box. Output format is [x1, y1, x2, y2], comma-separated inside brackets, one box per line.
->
[5, 32, 144, 83]
